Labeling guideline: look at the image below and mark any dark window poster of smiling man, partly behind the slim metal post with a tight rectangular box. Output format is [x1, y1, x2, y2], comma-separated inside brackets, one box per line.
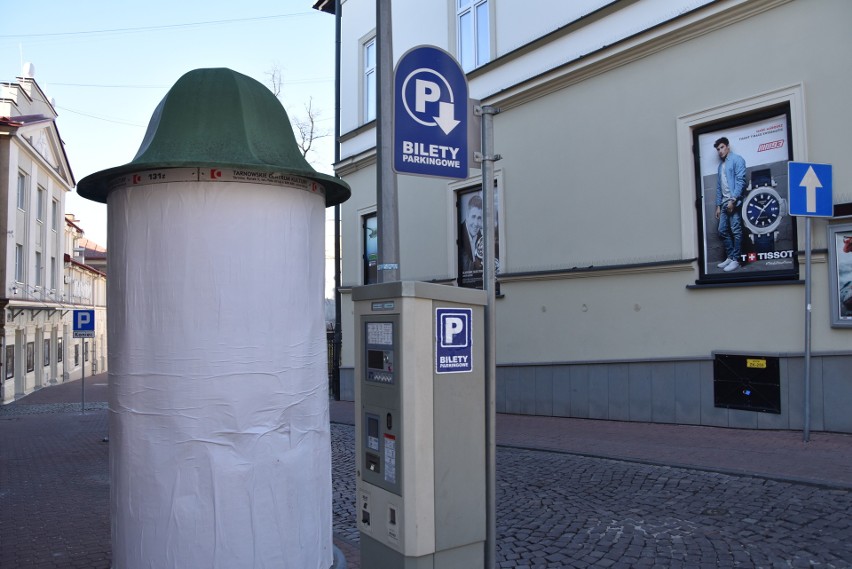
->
[456, 186, 500, 289]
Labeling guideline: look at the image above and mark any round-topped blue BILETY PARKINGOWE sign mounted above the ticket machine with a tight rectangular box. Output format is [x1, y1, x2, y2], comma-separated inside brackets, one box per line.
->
[393, 46, 469, 179]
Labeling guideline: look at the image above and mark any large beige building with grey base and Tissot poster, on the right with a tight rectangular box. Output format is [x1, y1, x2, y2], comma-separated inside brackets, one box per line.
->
[322, 0, 852, 432]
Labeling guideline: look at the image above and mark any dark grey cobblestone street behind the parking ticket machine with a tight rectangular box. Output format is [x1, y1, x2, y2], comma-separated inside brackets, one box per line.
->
[332, 425, 852, 569]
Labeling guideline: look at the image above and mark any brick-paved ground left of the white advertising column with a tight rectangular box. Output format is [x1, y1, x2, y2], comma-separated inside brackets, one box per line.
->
[0, 403, 110, 569]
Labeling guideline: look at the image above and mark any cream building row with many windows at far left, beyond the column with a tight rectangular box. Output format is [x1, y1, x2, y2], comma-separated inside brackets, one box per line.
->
[0, 64, 107, 403]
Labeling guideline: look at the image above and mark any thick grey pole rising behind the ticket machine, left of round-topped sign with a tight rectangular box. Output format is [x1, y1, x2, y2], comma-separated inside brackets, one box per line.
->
[376, 0, 399, 282]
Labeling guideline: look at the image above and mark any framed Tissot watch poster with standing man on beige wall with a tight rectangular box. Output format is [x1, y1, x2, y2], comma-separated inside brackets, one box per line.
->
[694, 109, 799, 283]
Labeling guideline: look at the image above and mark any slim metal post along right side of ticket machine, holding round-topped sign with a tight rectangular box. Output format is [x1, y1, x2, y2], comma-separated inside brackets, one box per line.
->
[480, 106, 500, 569]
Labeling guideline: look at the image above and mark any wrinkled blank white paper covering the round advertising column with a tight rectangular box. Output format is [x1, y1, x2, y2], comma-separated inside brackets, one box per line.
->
[108, 181, 333, 569]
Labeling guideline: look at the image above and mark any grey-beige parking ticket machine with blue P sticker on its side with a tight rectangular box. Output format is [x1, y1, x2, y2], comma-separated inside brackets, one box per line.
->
[352, 281, 487, 569]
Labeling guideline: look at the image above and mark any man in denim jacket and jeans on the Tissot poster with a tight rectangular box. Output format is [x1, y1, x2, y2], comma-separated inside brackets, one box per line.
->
[713, 136, 746, 273]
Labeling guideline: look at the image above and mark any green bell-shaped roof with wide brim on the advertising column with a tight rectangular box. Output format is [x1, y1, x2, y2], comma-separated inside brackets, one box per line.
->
[77, 68, 351, 206]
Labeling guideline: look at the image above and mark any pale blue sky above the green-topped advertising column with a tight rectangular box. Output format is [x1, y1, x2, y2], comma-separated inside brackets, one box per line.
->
[0, 0, 334, 248]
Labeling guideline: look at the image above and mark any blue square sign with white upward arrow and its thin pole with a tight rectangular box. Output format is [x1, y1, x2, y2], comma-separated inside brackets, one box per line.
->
[787, 162, 834, 442]
